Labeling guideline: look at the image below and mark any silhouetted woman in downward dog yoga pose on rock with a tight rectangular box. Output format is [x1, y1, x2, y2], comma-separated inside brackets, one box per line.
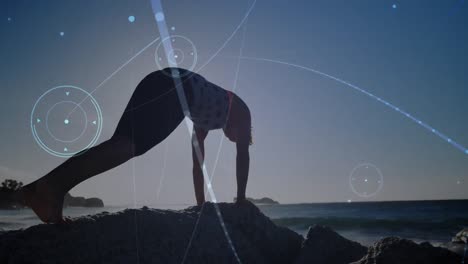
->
[18, 68, 252, 223]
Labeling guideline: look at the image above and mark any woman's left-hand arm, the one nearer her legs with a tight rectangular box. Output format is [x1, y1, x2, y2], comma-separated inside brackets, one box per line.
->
[192, 127, 208, 205]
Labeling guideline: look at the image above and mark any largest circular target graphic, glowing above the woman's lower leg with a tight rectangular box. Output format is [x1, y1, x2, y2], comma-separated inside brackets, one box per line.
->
[31, 85, 102, 158]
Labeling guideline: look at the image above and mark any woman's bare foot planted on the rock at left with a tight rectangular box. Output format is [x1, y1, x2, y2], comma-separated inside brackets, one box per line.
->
[17, 181, 66, 223]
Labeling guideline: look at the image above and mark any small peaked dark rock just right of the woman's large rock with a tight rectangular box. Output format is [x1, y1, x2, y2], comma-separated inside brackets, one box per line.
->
[295, 225, 367, 264]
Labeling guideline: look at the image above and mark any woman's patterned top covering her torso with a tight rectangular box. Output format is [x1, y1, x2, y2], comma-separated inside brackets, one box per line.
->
[187, 73, 231, 131]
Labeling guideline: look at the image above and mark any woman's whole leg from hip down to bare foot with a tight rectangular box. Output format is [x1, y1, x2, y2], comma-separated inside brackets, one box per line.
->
[19, 73, 184, 223]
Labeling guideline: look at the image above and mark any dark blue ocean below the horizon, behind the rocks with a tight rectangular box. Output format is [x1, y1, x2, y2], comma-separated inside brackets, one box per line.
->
[0, 200, 468, 246]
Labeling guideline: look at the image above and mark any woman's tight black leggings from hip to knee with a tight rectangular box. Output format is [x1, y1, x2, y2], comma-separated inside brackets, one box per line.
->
[113, 71, 185, 156]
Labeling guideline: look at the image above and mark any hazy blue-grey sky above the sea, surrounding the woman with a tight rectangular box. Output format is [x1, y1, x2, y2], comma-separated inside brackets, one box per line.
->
[0, 0, 468, 206]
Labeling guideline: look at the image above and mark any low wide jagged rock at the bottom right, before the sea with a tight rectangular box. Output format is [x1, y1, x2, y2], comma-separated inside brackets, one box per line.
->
[353, 237, 462, 264]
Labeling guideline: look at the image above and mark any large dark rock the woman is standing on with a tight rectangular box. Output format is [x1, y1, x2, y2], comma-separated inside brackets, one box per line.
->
[0, 203, 303, 264]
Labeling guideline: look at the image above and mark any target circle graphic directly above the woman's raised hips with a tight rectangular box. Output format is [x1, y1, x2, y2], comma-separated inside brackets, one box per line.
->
[154, 35, 198, 77]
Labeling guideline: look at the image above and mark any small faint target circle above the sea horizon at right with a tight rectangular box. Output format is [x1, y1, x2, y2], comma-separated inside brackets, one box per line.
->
[349, 163, 383, 198]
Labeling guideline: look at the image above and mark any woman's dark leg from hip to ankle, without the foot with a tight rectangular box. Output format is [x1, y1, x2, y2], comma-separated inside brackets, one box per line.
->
[40, 71, 190, 194]
